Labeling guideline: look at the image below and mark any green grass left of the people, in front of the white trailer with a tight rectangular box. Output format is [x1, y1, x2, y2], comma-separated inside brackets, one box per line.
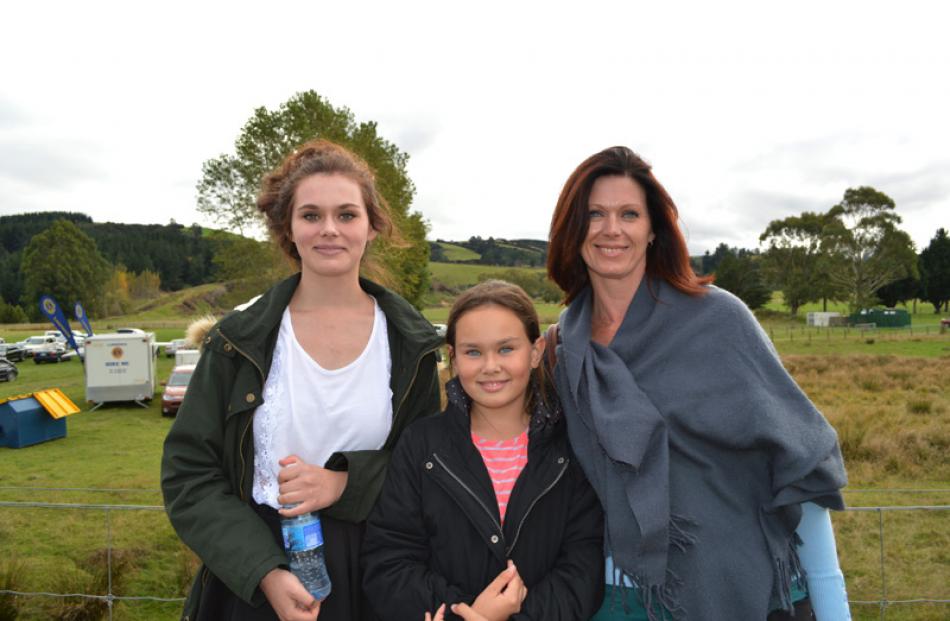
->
[0, 352, 188, 621]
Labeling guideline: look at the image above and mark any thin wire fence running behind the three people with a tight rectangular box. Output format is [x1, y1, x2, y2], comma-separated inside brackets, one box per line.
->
[0, 486, 950, 621]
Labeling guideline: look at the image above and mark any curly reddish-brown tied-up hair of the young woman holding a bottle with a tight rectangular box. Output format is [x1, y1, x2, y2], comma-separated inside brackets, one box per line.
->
[257, 139, 406, 284]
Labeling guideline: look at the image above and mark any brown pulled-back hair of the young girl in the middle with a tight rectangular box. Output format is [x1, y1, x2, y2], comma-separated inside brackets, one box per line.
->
[445, 280, 549, 414]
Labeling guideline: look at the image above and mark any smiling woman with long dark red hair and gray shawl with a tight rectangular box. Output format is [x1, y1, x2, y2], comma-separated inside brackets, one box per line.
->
[547, 147, 850, 621]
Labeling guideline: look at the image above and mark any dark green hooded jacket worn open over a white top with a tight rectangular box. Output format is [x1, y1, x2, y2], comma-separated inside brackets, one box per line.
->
[162, 274, 442, 620]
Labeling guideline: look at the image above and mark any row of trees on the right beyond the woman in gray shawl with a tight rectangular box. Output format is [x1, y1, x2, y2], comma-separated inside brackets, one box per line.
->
[700, 186, 950, 315]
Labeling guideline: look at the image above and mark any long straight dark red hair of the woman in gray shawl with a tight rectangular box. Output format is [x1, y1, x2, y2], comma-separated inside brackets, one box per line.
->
[547, 147, 712, 304]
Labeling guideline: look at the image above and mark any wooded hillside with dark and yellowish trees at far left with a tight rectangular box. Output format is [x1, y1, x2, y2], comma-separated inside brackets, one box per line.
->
[0, 212, 223, 323]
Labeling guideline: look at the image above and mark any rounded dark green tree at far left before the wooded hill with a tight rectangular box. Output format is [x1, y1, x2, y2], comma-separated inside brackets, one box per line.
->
[20, 220, 112, 319]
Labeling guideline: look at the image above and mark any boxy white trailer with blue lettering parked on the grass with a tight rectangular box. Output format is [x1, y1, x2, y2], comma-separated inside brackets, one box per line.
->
[84, 331, 157, 410]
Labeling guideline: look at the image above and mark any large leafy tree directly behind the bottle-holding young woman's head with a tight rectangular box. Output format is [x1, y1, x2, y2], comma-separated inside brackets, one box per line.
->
[197, 90, 429, 305]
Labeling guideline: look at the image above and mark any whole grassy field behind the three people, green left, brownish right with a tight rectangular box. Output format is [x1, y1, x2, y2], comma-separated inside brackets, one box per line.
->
[0, 284, 950, 621]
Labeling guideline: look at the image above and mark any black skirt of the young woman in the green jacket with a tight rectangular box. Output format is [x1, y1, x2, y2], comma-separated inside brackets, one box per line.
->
[195, 504, 377, 621]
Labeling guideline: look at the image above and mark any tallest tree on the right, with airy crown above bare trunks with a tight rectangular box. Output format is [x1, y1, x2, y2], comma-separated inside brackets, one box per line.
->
[822, 186, 917, 311]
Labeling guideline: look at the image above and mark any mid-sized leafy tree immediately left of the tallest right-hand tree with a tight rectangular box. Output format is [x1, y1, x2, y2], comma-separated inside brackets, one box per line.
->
[759, 212, 838, 315]
